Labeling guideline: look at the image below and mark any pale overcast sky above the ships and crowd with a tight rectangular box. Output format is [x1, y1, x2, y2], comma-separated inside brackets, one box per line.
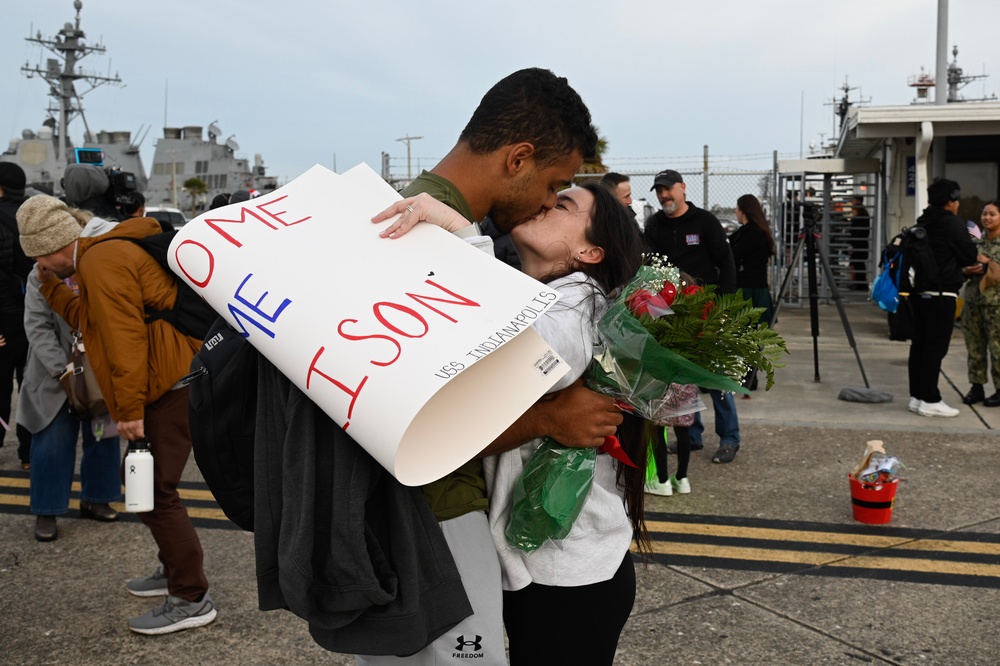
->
[0, 0, 1000, 183]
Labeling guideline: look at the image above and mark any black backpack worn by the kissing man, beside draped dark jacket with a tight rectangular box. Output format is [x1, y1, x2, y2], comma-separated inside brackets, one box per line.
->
[188, 317, 260, 532]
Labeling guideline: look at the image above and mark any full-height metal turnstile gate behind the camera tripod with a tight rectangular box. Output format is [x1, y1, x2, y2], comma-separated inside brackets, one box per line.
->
[771, 158, 885, 307]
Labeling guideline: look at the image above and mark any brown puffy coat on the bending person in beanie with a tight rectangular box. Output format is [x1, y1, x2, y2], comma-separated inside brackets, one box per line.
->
[41, 217, 201, 421]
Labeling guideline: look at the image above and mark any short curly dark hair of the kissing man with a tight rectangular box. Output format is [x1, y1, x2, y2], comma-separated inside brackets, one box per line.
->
[459, 67, 597, 164]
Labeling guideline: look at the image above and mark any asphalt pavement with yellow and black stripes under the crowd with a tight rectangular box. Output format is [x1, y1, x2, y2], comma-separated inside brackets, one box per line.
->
[0, 304, 1000, 666]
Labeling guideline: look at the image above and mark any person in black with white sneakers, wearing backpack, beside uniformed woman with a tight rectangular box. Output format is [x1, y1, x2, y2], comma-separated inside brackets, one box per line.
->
[907, 178, 988, 417]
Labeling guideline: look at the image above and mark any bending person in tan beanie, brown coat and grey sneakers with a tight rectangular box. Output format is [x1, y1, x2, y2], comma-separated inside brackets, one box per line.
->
[17, 196, 216, 635]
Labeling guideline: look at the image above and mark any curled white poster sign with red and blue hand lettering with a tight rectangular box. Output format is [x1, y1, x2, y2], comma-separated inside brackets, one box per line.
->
[170, 165, 569, 485]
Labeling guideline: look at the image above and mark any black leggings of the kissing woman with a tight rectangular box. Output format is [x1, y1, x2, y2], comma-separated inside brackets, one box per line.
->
[503, 553, 635, 666]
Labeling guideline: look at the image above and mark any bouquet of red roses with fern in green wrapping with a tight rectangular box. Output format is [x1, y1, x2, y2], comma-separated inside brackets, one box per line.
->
[506, 256, 788, 552]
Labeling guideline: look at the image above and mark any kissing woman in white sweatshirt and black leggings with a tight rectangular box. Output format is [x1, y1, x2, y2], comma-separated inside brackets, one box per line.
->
[382, 182, 649, 665]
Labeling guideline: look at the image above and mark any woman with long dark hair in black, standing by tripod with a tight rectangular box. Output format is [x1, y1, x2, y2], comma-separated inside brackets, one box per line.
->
[729, 194, 775, 390]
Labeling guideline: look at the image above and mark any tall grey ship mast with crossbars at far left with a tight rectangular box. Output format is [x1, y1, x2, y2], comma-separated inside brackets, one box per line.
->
[21, 0, 122, 175]
